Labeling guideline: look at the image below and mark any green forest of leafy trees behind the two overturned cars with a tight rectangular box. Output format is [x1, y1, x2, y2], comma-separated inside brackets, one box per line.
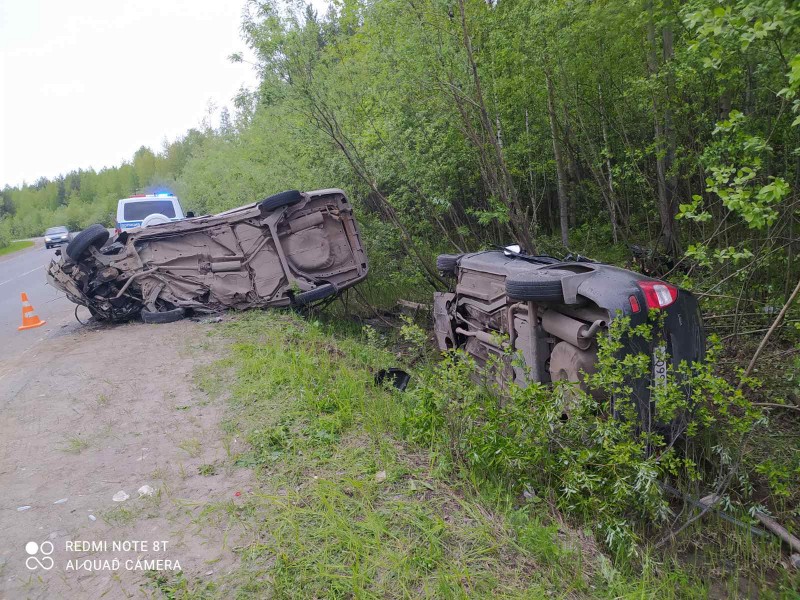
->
[0, 0, 800, 309]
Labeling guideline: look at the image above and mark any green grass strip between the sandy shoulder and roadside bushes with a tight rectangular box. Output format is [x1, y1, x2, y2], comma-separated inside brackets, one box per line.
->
[161, 312, 736, 598]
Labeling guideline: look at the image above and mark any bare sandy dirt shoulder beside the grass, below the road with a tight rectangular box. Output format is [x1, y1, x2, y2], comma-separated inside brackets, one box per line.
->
[0, 321, 250, 598]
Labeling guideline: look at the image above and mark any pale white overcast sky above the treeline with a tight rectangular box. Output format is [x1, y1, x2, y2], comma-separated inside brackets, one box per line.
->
[0, 0, 256, 187]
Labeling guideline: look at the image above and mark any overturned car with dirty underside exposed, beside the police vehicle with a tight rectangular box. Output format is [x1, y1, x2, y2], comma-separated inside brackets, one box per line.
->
[47, 189, 368, 323]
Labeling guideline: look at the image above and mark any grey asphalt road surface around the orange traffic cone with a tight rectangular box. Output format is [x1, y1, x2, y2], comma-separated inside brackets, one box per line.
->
[0, 238, 77, 368]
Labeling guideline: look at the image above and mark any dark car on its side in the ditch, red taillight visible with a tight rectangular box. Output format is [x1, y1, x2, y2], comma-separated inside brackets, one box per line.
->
[434, 246, 705, 429]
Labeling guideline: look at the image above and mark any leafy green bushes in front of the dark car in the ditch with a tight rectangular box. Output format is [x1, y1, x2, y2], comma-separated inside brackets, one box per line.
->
[403, 319, 766, 557]
